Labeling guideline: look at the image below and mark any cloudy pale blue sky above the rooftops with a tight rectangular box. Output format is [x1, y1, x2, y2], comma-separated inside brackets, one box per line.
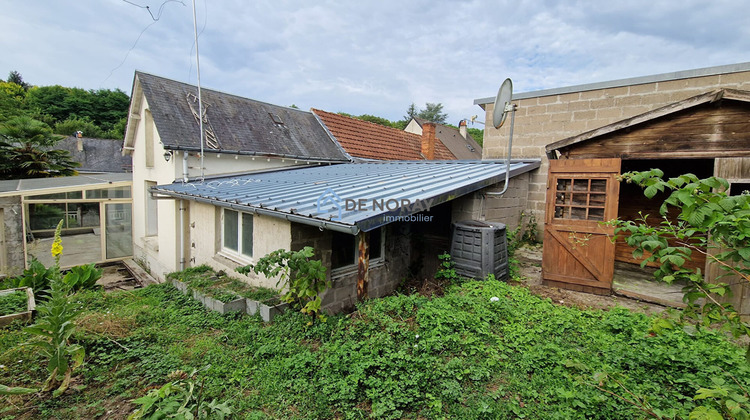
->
[0, 0, 750, 124]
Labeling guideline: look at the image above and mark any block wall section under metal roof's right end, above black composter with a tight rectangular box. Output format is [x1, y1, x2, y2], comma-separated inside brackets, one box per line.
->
[451, 172, 531, 231]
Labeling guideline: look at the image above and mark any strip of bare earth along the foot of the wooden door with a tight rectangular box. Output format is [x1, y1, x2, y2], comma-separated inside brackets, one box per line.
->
[514, 245, 666, 315]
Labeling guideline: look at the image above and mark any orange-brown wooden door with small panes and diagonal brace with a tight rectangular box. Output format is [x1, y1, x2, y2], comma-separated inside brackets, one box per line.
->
[542, 159, 620, 294]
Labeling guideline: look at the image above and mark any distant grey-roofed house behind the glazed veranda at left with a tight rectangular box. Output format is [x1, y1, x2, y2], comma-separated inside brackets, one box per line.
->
[55, 136, 133, 174]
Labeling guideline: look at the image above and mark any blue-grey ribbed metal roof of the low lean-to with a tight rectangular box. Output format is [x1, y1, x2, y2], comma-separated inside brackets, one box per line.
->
[153, 160, 540, 234]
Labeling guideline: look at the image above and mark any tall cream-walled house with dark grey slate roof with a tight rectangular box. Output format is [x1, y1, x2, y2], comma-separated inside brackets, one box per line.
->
[123, 72, 350, 279]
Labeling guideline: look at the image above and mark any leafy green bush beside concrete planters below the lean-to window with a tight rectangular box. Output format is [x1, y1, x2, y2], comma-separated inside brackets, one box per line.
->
[237, 246, 331, 324]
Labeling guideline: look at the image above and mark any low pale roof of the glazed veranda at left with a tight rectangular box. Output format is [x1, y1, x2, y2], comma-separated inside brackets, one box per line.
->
[0, 173, 133, 196]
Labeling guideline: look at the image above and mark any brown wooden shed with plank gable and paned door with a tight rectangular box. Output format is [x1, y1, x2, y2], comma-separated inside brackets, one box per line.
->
[542, 89, 750, 314]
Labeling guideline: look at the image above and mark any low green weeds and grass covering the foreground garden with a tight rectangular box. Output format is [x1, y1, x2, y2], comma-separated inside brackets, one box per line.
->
[0, 281, 750, 419]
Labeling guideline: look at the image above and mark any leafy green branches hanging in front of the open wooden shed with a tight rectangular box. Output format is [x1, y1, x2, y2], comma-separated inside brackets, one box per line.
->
[614, 169, 750, 356]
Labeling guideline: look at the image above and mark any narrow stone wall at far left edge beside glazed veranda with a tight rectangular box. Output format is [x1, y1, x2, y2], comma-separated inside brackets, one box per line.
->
[0, 196, 25, 277]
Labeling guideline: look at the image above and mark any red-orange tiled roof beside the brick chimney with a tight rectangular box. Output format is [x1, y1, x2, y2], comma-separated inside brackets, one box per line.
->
[312, 109, 456, 160]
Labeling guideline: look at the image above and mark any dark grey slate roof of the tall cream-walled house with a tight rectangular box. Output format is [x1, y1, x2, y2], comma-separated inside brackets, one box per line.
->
[133, 72, 350, 162]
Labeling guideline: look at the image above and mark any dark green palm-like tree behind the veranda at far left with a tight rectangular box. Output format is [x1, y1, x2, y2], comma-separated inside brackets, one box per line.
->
[0, 116, 80, 179]
